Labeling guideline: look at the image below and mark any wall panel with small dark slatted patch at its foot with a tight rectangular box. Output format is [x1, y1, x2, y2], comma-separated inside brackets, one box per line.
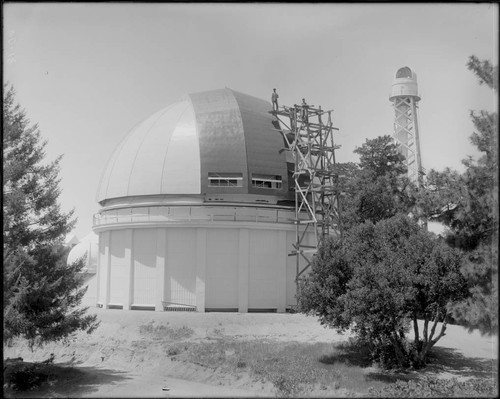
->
[165, 228, 196, 306]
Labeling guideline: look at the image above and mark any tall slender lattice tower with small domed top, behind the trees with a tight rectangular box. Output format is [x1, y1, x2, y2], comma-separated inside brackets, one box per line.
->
[389, 67, 424, 187]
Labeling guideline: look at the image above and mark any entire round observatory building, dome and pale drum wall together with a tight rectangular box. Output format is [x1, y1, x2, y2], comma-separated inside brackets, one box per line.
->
[91, 88, 315, 312]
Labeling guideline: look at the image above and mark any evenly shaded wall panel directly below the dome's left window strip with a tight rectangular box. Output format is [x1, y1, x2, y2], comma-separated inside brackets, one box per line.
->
[205, 229, 238, 308]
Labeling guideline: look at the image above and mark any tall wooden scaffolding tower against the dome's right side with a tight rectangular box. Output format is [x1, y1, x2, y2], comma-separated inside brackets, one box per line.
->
[271, 101, 340, 294]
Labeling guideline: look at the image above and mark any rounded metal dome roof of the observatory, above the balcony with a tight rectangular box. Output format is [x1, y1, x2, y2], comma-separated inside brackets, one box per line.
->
[97, 88, 288, 206]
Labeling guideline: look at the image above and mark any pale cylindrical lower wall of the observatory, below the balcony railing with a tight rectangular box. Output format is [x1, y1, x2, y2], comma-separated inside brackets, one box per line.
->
[96, 225, 310, 312]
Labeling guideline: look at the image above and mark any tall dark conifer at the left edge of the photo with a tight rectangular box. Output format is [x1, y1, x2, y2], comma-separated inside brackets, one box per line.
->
[3, 86, 98, 346]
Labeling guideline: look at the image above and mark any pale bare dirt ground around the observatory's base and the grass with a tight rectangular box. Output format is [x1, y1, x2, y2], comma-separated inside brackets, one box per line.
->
[4, 308, 498, 397]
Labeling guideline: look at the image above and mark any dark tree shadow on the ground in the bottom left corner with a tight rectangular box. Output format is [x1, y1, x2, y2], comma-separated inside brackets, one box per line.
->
[4, 363, 130, 398]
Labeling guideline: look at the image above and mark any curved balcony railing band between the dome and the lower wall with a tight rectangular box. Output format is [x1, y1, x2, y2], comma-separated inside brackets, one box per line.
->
[93, 206, 295, 227]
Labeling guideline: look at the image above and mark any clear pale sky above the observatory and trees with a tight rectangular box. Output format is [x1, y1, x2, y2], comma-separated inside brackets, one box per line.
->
[3, 2, 499, 239]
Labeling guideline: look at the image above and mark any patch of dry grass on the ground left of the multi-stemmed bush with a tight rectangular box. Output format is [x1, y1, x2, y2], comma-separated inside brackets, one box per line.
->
[177, 337, 387, 397]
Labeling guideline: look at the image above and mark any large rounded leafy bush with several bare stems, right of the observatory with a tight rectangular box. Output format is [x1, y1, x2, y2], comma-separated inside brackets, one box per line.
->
[298, 215, 467, 368]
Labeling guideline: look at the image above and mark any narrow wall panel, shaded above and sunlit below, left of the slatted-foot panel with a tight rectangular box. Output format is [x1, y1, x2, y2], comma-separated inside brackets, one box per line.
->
[132, 229, 157, 306]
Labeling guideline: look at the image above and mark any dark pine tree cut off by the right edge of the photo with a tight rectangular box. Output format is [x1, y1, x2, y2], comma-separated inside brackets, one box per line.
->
[419, 56, 498, 333]
